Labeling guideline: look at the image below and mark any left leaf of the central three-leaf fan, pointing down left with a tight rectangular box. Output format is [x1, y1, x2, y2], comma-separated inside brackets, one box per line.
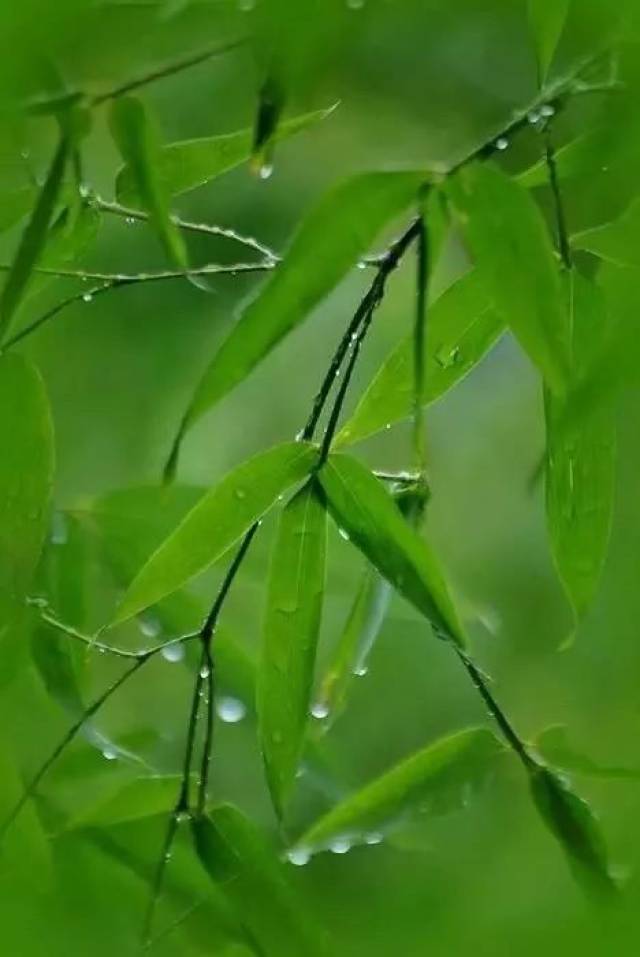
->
[113, 442, 317, 624]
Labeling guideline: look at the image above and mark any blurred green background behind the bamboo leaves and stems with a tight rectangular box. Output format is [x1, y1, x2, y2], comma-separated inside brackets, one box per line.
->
[0, 0, 640, 957]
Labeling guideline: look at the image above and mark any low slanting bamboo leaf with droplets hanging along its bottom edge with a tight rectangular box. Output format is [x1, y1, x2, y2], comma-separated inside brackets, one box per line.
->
[296, 728, 504, 852]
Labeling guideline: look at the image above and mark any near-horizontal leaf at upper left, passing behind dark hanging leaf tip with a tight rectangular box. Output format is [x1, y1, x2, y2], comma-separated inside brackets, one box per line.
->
[116, 107, 335, 206]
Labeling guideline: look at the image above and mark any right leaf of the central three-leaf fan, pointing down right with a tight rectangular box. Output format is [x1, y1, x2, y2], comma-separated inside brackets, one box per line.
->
[319, 455, 465, 646]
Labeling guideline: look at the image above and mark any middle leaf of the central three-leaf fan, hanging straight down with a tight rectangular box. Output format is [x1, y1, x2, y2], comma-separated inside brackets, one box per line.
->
[257, 482, 327, 817]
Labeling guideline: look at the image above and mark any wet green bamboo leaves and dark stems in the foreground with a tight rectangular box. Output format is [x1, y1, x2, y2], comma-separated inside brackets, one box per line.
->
[0, 2, 640, 957]
